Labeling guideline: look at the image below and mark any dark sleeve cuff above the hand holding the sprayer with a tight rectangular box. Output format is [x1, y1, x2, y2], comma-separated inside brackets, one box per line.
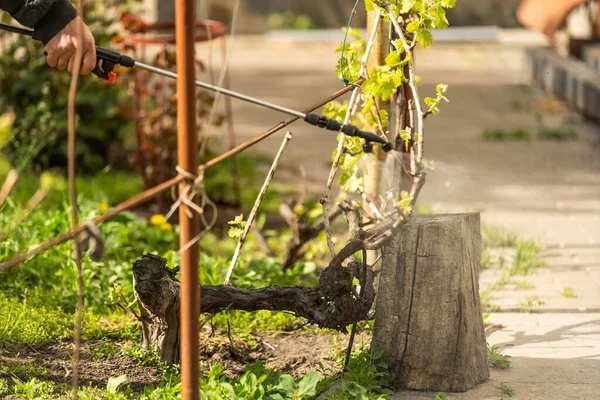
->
[0, 0, 77, 45]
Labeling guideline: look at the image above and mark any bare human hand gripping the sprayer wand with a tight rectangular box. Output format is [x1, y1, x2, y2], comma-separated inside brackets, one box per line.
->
[45, 17, 96, 75]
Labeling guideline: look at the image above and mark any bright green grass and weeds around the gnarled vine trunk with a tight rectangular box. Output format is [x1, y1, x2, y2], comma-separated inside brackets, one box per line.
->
[0, 165, 352, 399]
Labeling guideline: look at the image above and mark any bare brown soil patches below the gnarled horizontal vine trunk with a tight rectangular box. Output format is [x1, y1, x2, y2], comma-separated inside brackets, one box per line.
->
[0, 331, 348, 392]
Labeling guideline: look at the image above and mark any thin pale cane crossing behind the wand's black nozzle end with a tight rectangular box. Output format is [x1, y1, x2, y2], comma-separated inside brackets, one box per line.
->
[321, 12, 381, 257]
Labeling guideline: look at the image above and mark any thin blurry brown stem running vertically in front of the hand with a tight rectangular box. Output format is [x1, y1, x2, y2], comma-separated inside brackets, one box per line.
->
[68, 0, 83, 399]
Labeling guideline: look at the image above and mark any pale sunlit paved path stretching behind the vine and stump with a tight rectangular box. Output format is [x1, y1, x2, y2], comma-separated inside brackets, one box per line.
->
[193, 29, 600, 400]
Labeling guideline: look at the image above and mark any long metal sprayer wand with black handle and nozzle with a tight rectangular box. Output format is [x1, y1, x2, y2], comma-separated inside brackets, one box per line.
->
[0, 24, 392, 153]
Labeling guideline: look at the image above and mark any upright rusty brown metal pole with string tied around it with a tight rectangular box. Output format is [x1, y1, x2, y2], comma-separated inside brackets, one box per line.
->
[175, 0, 200, 400]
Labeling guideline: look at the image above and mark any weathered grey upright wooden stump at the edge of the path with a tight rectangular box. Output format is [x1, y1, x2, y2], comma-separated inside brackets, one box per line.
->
[372, 214, 489, 392]
